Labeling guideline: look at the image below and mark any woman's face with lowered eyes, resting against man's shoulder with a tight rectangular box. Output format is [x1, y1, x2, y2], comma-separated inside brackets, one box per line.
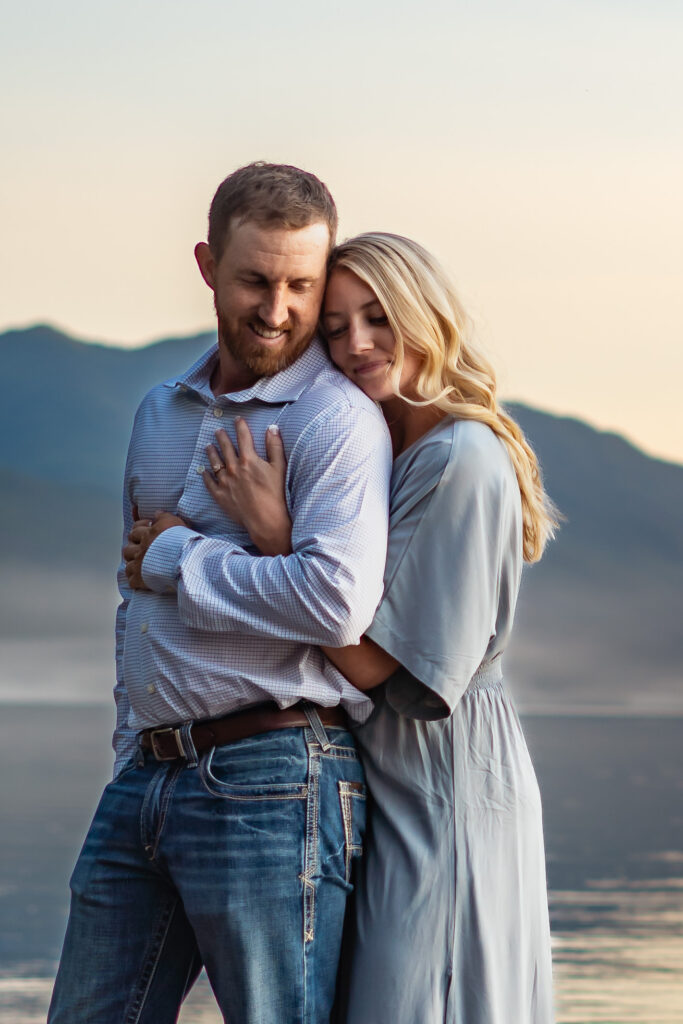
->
[323, 267, 420, 401]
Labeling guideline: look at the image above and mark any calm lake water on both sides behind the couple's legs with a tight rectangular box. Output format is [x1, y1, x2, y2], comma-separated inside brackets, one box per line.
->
[0, 705, 683, 1024]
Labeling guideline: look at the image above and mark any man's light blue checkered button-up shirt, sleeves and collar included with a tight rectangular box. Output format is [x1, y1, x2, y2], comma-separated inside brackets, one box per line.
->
[114, 341, 391, 773]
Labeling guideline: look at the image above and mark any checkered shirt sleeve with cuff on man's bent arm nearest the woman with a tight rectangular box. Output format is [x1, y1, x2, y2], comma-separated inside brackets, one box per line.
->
[142, 406, 391, 647]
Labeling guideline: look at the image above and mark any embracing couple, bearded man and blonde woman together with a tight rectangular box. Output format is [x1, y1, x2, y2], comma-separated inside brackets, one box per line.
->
[49, 164, 553, 1024]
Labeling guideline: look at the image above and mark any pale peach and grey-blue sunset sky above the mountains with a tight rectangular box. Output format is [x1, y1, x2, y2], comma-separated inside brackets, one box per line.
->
[0, 0, 683, 461]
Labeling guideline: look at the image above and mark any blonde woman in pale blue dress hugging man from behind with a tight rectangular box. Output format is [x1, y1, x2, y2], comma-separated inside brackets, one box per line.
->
[202, 233, 554, 1024]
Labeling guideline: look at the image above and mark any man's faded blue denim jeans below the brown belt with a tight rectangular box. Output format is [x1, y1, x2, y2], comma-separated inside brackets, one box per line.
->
[48, 720, 366, 1024]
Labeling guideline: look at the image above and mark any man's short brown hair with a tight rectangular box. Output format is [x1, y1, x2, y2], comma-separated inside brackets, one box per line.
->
[209, 161, 337, 260]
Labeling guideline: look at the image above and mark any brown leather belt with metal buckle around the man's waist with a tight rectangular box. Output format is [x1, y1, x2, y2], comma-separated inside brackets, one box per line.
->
[139, 703, 348, 761]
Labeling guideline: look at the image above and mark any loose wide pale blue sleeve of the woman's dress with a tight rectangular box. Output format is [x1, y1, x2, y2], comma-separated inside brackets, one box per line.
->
[368, 428, 516, 719]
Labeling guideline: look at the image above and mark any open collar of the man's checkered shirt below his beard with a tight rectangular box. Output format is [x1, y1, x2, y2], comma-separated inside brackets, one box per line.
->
[166, 338, 330, 404]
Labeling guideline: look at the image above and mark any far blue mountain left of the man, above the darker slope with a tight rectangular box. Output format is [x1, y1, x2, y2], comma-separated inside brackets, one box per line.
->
[0, 326, 216, 493]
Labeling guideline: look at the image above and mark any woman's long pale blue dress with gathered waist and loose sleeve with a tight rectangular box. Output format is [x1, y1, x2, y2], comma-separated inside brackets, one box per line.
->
[342, 418, 553, 1024]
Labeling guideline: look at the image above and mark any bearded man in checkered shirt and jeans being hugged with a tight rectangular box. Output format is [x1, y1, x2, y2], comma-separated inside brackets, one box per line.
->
[49, 164, 391, 1024]
